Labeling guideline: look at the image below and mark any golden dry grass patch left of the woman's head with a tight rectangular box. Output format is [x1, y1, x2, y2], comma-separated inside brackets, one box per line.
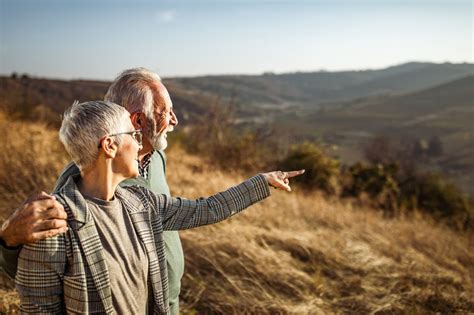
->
[0, 112, 68, 219]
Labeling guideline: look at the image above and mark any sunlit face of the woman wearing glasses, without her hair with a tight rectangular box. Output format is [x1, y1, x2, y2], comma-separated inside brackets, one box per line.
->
[112, 116, 140, 178]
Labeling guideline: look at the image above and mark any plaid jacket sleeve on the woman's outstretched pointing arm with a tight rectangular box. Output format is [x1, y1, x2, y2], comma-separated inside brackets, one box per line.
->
[144, 175, 270, 230]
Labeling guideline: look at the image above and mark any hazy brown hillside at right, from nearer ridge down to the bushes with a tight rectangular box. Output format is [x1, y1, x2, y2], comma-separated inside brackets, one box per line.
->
[275, 76, 474, 196]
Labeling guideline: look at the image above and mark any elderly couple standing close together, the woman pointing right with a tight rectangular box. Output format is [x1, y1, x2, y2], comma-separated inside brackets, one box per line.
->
[0, 68, 303, 314]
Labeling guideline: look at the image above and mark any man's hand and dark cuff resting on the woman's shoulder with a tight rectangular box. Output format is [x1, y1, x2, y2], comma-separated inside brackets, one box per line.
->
[0, 192, 67, 278]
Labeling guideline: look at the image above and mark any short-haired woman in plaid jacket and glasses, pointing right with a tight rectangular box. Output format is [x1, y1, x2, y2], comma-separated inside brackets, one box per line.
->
[15, 101, 303, 314]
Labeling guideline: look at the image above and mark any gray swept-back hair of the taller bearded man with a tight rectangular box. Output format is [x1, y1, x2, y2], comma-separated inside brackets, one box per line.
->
[104, 68, 161, 120]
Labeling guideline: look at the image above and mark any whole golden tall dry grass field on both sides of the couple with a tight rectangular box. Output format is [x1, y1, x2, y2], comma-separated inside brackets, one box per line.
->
[0, 116, 474, 314]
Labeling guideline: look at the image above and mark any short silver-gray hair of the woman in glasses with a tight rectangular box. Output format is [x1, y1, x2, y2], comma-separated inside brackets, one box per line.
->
[59, 101, 128, 170]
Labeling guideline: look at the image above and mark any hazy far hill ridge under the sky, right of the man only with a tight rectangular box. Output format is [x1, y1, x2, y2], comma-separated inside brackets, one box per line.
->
[169, 62, 474, 107]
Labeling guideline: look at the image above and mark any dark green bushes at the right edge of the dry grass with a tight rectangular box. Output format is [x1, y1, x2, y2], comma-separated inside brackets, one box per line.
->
[342, 163, 473, 230]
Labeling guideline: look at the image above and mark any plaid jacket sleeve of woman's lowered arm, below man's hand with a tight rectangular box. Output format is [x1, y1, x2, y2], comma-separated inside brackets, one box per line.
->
[15, 234, 66, 314]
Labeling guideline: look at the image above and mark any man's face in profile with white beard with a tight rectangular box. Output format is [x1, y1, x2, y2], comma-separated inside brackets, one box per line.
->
[145, 82, 178, 150]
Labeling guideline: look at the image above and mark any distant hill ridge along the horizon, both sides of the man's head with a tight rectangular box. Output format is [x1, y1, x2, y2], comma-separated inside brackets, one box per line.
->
[0, 62, 474, 113]
